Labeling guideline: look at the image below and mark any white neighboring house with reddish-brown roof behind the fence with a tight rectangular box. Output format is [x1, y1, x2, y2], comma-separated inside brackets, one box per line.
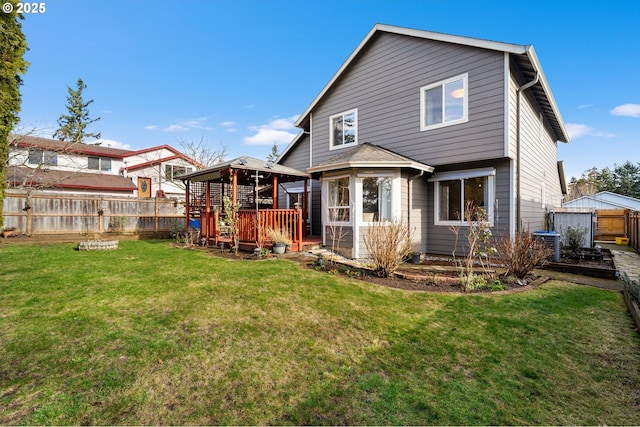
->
[7, 135, 202, 199]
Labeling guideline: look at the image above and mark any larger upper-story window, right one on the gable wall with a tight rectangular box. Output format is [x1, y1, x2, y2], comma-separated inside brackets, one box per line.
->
[420, 73, 469, 130]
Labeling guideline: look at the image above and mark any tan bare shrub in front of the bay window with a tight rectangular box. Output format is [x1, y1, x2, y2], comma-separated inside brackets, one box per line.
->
[364, 221, 413, 277]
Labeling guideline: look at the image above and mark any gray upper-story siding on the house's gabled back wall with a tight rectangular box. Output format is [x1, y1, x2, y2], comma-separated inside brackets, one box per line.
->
[313, 33, 505, 166]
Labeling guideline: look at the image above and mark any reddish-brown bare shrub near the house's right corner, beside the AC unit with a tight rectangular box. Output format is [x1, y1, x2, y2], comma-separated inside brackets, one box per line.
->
[495, 230, 553, 279]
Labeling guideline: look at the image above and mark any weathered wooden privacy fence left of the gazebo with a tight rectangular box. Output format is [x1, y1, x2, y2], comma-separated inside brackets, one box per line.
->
[3, 192, 185, 235]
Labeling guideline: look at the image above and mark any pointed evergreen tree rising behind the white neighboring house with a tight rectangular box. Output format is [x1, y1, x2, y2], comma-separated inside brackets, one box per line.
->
[53, 79, 100, 143]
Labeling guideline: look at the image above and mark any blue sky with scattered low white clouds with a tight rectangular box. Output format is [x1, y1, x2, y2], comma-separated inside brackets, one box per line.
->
[15, 0, 640, 181]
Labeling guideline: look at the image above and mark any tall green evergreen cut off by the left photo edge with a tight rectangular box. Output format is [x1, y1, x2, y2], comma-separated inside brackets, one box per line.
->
[0, 0, 29, 227]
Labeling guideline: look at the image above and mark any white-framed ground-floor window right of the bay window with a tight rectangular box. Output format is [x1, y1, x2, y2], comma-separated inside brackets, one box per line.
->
[430, 168, 495, 225]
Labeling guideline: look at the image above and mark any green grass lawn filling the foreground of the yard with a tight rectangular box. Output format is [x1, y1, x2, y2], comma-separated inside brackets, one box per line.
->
[0, 241, 640, 425]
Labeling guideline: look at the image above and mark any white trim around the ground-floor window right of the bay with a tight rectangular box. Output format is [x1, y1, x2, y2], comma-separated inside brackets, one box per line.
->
[429, 168, 496, 227]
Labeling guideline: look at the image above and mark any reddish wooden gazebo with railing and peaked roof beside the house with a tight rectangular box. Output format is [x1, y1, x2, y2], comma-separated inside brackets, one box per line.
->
[180, 156, 309, 251]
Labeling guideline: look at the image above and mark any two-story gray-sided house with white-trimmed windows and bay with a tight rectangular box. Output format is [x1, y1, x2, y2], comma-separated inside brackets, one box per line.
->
[278, 24, 569, 258]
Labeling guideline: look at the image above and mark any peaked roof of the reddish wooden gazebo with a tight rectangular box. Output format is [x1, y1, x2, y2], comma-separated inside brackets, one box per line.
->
[180, 156, 309, 185]
